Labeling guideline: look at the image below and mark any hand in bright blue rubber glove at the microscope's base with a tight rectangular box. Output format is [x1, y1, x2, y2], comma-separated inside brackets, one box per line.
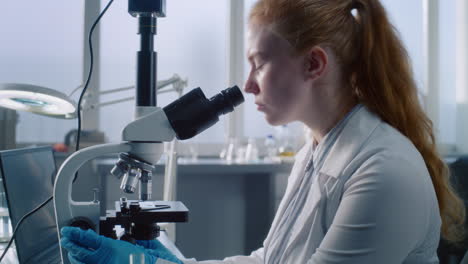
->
[60, 227, 181, 264]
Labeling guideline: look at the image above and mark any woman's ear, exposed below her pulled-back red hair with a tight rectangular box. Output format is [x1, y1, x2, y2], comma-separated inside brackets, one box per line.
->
[304, 46, 328, 80]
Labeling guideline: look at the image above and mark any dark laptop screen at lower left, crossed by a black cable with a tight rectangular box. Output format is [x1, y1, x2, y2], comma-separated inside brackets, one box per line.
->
[0, 147, 60, 264]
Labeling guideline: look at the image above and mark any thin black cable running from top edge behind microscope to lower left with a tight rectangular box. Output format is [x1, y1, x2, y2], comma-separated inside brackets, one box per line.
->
[0, 0, 114, 262]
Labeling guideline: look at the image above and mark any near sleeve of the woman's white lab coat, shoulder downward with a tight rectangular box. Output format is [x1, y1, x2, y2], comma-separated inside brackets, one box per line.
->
[308, 154, 431, 264]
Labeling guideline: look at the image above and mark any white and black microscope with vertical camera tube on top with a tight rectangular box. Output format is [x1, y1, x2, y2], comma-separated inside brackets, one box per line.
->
[54, 0, 244, 264]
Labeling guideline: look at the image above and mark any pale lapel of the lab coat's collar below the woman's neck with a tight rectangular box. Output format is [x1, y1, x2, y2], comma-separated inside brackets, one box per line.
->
[319, 106, 382, 178]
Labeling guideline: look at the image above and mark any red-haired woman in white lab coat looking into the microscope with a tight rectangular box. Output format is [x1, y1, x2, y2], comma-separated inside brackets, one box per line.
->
[60, 0, 465, 264]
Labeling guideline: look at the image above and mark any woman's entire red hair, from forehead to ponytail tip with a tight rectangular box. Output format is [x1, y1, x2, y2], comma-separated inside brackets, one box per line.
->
[250, 0, 465, 242]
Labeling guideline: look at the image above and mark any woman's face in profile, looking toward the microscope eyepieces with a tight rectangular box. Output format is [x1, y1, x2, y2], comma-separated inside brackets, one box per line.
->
[244, 24, 307, 125]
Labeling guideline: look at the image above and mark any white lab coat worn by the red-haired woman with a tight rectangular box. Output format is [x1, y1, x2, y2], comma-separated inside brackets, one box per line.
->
[184, 107, 441, 264]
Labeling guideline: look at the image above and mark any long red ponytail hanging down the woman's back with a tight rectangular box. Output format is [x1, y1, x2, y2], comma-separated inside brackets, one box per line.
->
[351, 0, 465, 242]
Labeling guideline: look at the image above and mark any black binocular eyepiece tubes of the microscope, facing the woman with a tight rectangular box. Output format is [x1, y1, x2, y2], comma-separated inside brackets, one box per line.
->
[163, 86, 244, 139]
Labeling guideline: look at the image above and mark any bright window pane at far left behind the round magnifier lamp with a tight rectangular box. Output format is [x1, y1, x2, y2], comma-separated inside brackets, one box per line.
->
[0, 0, 83, 142]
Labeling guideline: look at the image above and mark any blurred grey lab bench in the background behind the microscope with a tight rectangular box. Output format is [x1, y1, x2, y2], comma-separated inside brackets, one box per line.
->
[58, 156, 292, 260]
